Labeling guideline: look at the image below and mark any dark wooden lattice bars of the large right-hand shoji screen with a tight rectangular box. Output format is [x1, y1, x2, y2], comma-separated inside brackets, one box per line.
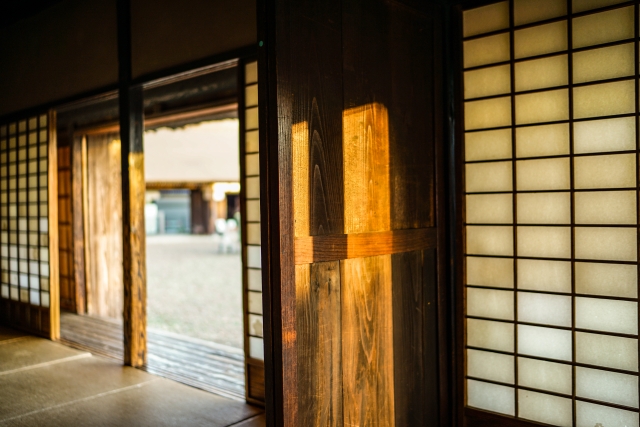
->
[455, 0, 640, 426]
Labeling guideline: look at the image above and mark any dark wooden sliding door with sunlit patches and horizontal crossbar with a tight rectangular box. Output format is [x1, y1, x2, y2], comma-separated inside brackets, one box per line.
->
[259, 0, 450, 426]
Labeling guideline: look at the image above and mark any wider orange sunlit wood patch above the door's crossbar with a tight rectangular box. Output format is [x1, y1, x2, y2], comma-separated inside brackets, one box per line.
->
[342, 103, 391, 234]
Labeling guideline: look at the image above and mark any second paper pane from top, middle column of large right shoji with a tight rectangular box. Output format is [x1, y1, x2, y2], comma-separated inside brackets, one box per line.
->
[514, 21, 567, 59]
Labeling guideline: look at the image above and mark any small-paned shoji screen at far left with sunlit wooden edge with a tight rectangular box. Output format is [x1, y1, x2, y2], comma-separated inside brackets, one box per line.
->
[0, 113, 59, 338]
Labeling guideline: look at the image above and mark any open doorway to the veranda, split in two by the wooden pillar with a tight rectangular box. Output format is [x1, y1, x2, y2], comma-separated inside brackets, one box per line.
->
[53, 61, 264, 404]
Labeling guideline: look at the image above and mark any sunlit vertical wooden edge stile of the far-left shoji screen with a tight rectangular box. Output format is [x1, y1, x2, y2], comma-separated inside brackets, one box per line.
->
[47, 110, 60, 340]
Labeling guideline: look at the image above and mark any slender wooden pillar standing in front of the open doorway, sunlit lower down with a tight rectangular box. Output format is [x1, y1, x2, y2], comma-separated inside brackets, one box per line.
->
[118, 0, 147, 367]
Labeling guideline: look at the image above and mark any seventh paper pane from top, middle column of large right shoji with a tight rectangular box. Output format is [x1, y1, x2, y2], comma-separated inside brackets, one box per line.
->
[517, 193, 571, 224]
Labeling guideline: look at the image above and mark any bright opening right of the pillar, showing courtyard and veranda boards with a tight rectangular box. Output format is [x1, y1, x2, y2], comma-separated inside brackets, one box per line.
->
[144, 117, 245, 397]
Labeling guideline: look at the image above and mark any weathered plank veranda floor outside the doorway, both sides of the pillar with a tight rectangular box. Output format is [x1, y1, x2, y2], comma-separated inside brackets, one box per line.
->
[60, 313, 245, 400]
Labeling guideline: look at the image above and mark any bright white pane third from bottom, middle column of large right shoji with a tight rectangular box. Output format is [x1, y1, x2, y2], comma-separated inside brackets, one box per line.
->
[518, 325, 571, 361]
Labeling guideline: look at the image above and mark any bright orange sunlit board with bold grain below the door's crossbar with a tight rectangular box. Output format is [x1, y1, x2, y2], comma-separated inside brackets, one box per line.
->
[340, 255, 395, 427]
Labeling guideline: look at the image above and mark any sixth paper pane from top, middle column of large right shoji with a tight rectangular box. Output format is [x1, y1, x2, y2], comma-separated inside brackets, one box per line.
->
[516, 158, 571, 191]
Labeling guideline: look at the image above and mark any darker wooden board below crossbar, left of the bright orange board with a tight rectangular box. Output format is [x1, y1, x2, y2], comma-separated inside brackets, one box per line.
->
[296, 262, 343, 426]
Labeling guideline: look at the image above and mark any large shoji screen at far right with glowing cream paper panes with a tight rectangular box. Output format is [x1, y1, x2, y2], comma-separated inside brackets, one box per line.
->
[463, 0, 639, 427]
